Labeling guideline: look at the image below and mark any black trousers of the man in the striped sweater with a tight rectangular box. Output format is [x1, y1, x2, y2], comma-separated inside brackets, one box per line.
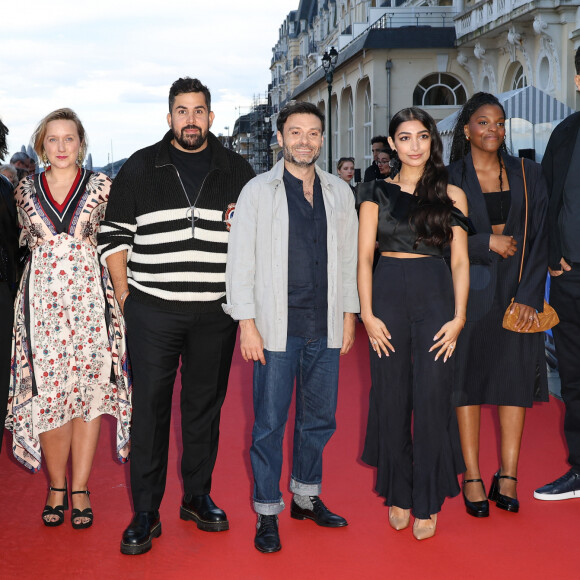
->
[125, 296, 237, 511]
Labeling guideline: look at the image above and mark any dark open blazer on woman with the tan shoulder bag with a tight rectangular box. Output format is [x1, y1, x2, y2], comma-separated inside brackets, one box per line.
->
[448, 154, 548, 320]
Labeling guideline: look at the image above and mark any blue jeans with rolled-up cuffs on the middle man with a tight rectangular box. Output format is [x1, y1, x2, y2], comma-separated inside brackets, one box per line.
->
[250, 336, 340, 515]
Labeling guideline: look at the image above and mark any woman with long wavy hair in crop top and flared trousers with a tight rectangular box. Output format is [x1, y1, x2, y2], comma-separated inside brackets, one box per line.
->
[357, 107, 469, 540]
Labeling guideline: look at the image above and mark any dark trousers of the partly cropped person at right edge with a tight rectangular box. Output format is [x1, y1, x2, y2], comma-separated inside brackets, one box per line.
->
[550, 264, 580, 472]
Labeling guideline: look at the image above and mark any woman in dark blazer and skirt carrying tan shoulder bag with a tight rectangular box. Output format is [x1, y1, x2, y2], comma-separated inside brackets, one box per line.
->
[449, 93, 548, 517]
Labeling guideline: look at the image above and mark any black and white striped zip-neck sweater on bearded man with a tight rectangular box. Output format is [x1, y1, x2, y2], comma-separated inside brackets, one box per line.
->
[98, 131, 254, 312]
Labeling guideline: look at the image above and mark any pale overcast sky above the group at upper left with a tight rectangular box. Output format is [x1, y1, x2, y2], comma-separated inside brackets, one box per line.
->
[0, 0, 299, 166]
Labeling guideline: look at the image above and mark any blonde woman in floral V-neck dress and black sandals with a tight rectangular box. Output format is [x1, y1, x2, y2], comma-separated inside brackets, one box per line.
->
[6, 109, 131, 528]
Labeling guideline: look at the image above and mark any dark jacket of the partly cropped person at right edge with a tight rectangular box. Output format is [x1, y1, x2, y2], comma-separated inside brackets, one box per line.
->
[542, 112, 580, 270]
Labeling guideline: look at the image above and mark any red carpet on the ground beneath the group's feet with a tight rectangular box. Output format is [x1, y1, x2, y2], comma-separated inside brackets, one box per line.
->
[0, 325, 580, 580]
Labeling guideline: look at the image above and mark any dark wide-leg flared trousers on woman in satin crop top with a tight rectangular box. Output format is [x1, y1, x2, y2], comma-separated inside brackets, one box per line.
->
[362, 256, 465, 519]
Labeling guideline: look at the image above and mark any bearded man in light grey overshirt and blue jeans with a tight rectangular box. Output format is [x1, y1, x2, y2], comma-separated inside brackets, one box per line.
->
[224, 102, 359, 552]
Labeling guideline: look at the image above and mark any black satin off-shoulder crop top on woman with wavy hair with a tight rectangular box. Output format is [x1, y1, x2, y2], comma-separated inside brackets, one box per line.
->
[357, 180, 473, 257]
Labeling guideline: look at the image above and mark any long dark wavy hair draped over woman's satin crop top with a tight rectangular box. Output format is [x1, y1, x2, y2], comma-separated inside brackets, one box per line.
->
[389, 107, 453, 249]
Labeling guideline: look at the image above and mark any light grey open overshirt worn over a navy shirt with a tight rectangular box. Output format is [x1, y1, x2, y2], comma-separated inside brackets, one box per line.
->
[223, 159, 360, 351]
